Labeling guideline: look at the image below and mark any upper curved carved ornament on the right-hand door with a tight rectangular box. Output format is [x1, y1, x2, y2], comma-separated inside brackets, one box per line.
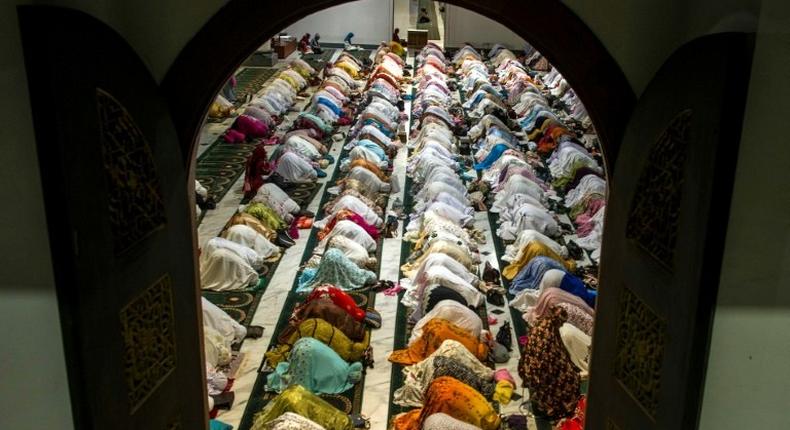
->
[626, 109, 691, 269]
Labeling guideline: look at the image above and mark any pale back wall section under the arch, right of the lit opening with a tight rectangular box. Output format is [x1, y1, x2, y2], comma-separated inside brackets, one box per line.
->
[444, 4, 525, 50]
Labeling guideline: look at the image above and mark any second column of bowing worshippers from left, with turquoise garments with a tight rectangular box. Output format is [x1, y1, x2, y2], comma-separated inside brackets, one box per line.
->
[244, 45, 403, 430]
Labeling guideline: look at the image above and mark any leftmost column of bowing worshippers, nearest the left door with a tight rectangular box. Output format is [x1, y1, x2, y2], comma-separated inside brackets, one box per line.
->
[197, 60, 338, 420]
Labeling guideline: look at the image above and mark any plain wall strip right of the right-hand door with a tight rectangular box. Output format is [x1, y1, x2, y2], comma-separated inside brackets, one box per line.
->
[700, 0, 790, 430]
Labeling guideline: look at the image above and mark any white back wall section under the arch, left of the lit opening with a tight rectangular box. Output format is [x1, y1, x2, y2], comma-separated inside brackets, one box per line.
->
[285, 0, 396, 45]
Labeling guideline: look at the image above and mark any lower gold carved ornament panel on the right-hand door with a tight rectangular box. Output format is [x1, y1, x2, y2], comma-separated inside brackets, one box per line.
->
[614, 287, 666, 417]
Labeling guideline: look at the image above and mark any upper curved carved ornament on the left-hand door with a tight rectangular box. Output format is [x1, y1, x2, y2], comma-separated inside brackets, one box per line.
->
[96, 88, 166, 255]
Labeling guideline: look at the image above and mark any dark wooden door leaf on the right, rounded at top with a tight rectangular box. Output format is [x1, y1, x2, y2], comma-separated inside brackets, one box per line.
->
[587, 33, 753, 430]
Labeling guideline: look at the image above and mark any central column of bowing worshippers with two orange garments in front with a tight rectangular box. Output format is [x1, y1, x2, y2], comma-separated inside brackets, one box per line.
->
[378, 44, 517, 430]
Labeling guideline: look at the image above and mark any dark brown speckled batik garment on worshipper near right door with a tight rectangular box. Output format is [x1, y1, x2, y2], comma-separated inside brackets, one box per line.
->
[518, 307, 581, 419]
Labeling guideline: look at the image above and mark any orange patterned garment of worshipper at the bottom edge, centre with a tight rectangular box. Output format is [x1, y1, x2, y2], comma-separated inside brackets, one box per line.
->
[393, 376, 501, 430]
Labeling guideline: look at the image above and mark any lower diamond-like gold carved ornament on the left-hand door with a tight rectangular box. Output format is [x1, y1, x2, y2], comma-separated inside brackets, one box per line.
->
[120, 275, 176, 413]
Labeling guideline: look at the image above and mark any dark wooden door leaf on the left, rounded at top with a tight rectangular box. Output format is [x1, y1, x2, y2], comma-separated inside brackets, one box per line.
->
[19, 6, 206, 429]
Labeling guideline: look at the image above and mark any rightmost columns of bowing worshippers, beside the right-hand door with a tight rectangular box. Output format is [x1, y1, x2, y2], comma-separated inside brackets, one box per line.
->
[455, 43, 606, 426]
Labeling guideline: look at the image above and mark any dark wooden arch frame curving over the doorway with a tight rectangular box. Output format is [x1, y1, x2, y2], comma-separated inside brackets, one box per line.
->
[162, 0, 636, 176]
